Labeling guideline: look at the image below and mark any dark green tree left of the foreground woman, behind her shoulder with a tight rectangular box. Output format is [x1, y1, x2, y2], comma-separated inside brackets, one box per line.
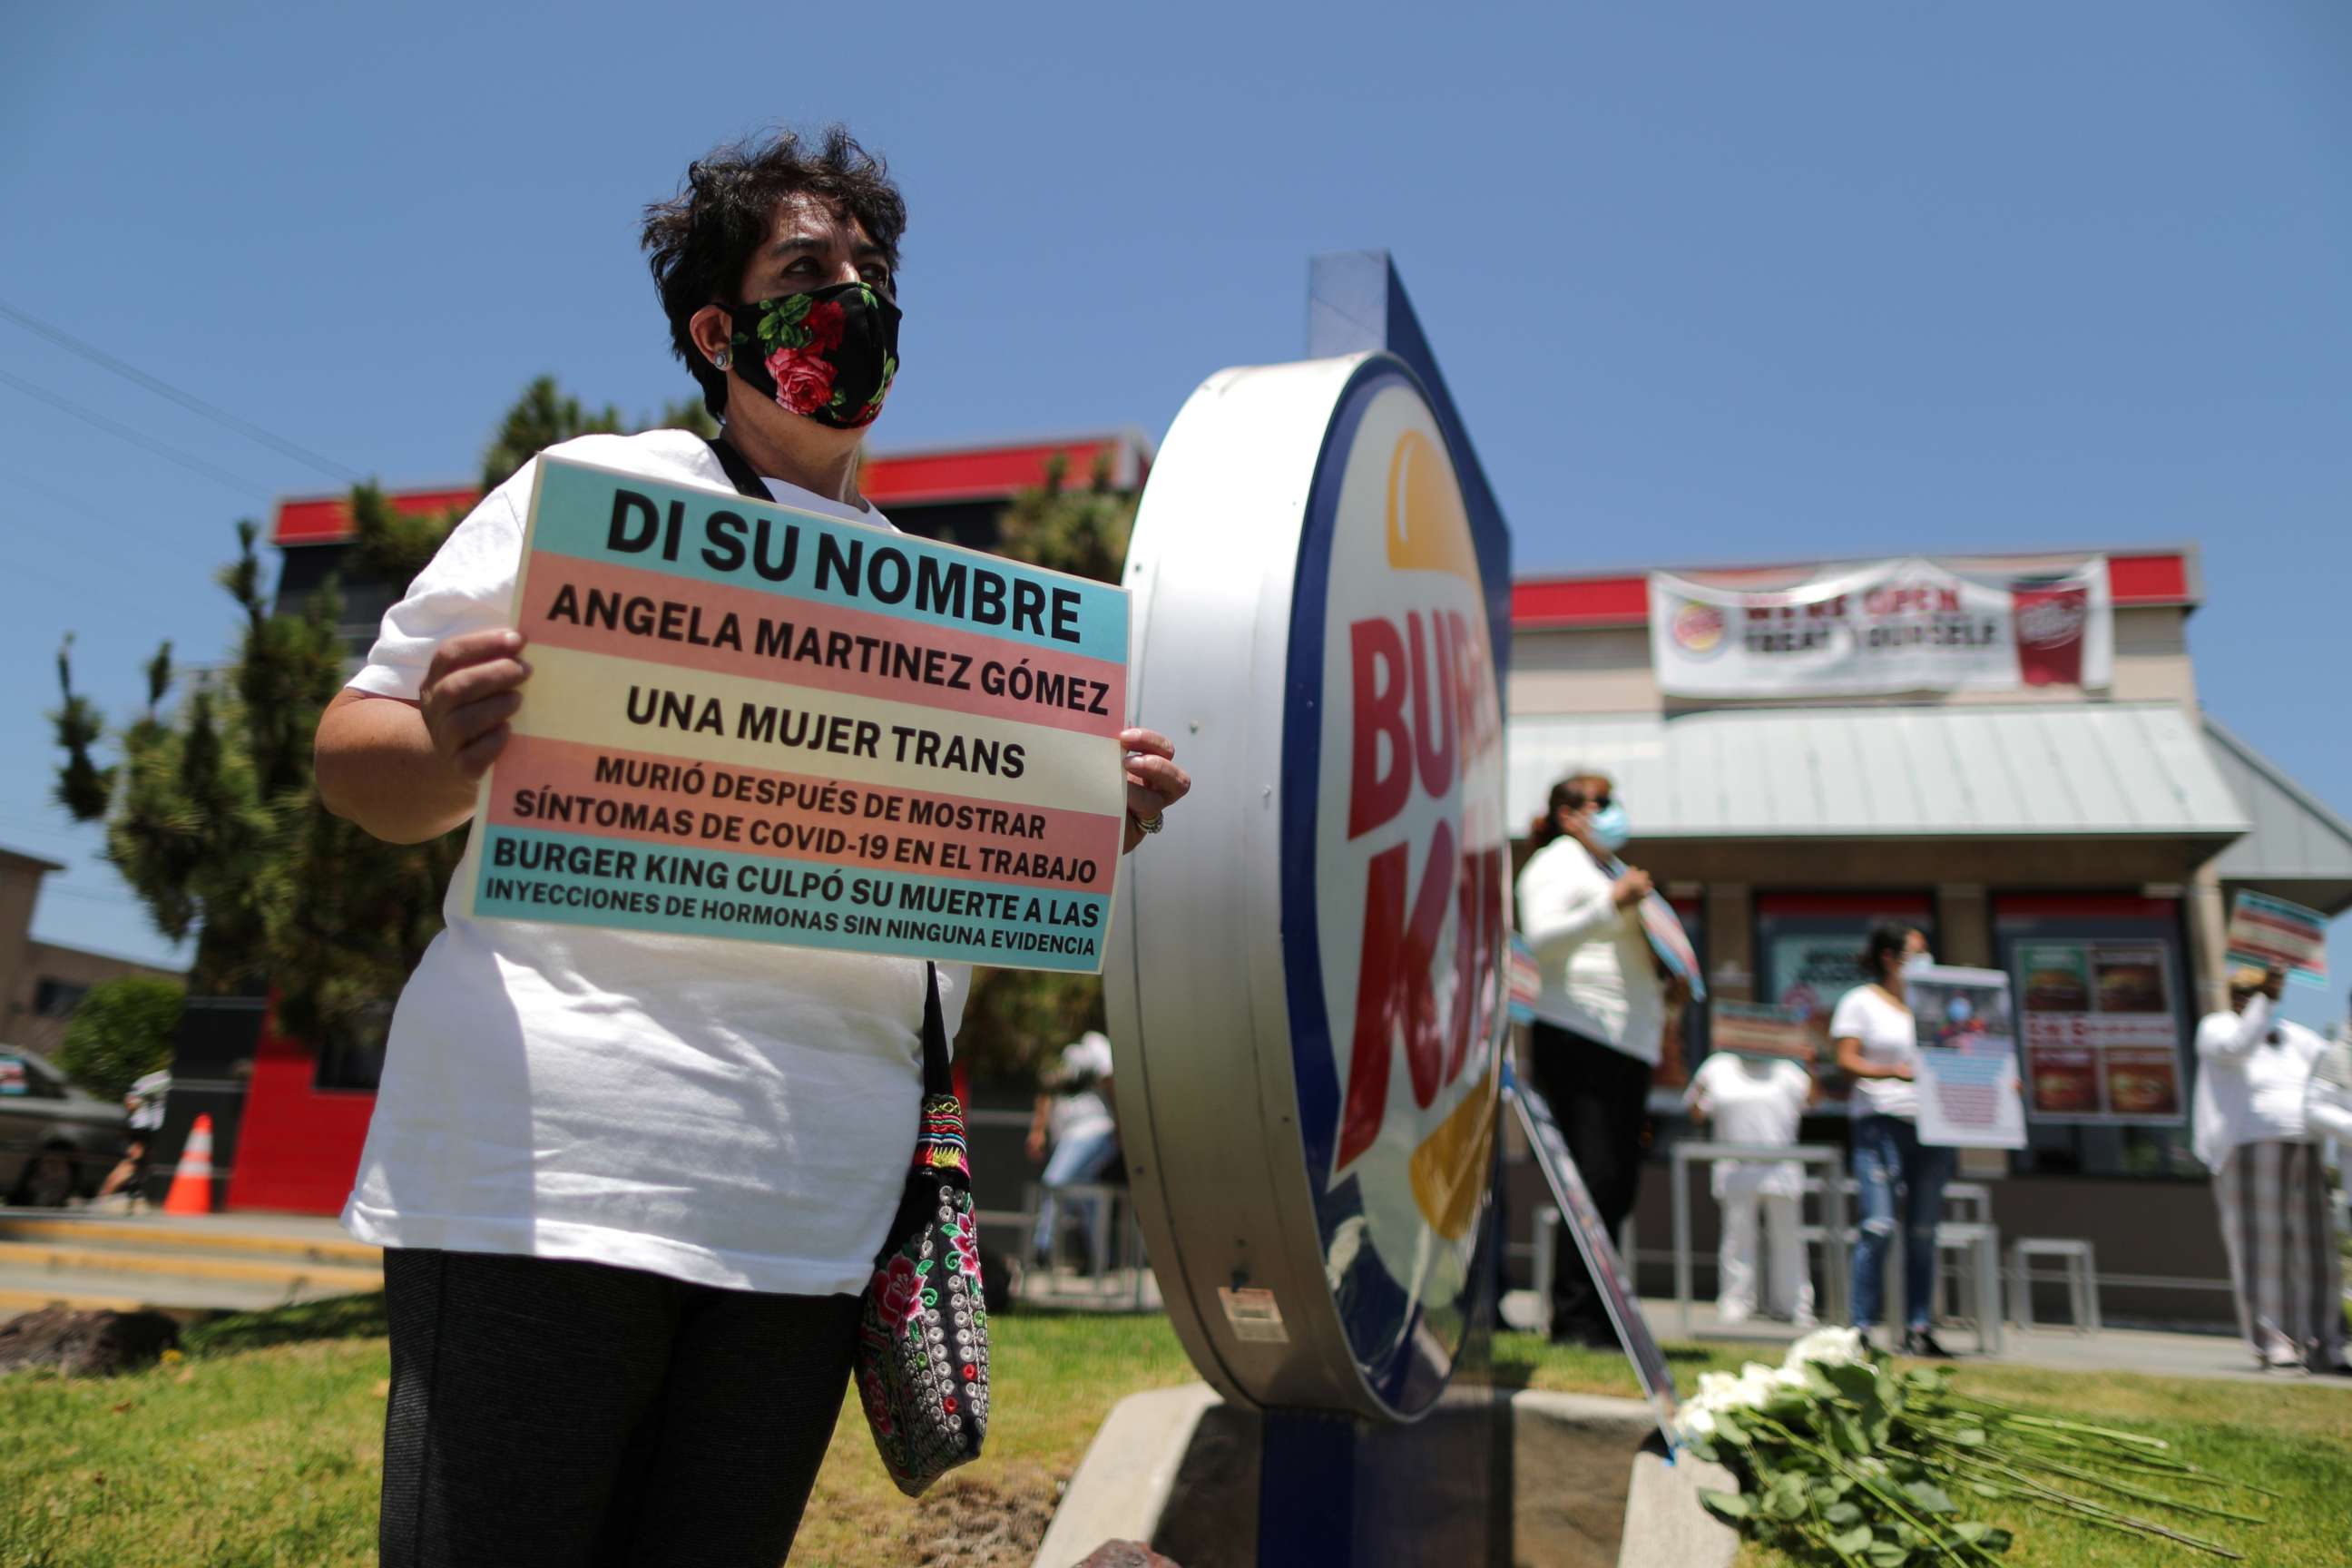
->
[52, 378, 708, 1037]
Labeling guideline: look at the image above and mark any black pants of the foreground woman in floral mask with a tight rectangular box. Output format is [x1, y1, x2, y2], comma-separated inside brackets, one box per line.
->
[378, 1249, 858, 1568]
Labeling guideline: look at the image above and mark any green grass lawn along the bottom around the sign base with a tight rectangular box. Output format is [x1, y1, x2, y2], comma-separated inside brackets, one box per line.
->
[0, 1298, 2352, 1568]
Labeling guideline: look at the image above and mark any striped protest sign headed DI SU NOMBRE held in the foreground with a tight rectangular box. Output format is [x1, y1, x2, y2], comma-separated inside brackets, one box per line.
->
[458, 456, 1127, 974]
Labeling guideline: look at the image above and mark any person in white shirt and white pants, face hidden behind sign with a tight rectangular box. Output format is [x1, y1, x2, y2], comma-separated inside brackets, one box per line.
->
[1681, 1051, 1813, 1328]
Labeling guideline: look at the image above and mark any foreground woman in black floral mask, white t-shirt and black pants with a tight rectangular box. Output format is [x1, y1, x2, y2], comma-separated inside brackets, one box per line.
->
[318, 127, 1191, 1568]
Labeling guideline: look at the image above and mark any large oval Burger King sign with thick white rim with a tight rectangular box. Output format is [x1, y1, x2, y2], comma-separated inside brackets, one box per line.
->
[1105, 353, 1510, 1420]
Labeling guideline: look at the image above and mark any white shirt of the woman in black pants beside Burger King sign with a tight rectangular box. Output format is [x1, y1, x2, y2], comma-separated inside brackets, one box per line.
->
[1519, 839, 1665, 1067]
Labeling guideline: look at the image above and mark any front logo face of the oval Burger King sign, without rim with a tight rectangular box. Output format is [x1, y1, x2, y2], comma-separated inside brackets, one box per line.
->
[1284, 362, 1510, 1406]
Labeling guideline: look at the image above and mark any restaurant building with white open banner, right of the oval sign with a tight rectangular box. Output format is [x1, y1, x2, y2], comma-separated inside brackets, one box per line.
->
[1507, 548, 2352, 1318]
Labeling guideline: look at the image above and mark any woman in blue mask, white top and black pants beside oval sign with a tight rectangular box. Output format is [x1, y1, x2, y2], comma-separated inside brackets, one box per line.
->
[1519, 769, 1668, 1347]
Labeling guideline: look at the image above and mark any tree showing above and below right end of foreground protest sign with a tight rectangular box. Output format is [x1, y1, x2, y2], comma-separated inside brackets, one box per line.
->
[957, 456, 1141, 1082]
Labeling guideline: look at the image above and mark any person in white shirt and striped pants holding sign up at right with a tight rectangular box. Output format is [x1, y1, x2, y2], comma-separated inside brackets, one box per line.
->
[2192, 966, 2345, 1373]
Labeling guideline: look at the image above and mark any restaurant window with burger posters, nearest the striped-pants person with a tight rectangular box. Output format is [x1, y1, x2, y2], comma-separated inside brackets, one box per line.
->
[1992, 893, 2204, 1175]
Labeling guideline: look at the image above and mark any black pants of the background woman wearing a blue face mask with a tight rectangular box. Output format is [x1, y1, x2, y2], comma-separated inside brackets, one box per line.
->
[1529, 1020, 1651, 1345]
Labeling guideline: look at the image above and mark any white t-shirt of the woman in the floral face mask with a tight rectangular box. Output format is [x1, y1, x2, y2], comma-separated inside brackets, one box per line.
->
[343, 430, 971, 1295]
